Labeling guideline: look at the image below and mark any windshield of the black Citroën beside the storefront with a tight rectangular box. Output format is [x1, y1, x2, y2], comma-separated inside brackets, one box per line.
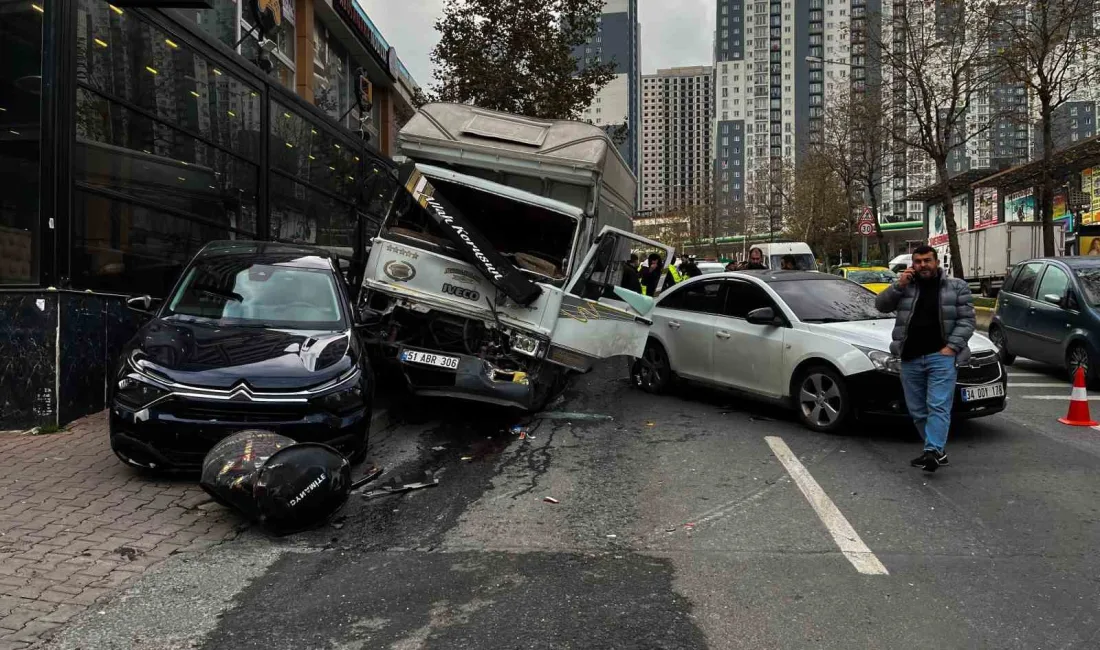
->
[164, 257, 347, 330]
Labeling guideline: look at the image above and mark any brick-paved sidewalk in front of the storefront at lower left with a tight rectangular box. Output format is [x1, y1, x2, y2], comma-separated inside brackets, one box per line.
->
[0, 411, 239, 650]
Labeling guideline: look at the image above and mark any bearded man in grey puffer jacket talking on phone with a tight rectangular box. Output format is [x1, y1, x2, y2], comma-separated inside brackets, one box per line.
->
[876, 245, 977, 472]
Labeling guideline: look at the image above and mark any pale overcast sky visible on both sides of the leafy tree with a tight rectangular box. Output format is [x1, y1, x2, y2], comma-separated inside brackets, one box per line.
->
[359, 0, 715, 87]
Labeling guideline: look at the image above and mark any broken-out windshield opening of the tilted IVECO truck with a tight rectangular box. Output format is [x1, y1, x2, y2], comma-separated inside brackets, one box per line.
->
[384, 178, 578, 283]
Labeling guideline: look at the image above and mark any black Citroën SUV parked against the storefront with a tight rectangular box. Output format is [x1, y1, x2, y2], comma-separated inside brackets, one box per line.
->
[108, 241, 374, 470]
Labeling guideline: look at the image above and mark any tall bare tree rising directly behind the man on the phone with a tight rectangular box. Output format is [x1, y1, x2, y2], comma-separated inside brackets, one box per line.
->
[870, 0, 1000, 277]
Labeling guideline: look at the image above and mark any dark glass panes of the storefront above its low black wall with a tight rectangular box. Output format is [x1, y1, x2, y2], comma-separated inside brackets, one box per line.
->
[0, 0, 393, 296]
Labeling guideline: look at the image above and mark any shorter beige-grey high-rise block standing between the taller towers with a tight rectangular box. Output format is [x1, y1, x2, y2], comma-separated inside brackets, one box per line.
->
[639, 66, 714, 212]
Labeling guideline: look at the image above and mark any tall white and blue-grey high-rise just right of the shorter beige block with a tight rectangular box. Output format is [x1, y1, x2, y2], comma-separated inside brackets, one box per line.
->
[714, 0, 881, 233]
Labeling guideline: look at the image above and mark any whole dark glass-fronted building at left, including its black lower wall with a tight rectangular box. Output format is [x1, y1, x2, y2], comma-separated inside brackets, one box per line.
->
[0, 0, 397, 429]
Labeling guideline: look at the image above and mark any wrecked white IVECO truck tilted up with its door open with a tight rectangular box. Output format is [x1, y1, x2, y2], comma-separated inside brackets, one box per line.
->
[360, 103, 672, 410]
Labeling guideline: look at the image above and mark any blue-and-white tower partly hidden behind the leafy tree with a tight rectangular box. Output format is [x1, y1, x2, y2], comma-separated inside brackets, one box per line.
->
[573, 0, 641, 175]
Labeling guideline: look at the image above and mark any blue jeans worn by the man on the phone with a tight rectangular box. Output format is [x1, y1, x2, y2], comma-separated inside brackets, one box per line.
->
[901, 352, 958, 453]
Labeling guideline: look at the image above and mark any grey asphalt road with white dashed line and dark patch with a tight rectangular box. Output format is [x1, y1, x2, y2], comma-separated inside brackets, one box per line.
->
[47, 361, 1100, 650]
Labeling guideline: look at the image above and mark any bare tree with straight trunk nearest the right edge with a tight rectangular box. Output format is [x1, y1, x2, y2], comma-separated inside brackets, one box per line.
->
[991, 0, 1100, 255]
